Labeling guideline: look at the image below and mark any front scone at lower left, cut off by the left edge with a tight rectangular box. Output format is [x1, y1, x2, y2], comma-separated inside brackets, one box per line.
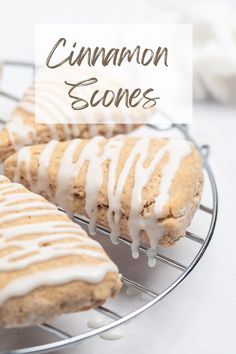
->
[0, 176, 121, 327]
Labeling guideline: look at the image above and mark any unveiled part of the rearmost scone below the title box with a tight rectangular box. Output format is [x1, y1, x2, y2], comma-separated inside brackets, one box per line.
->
[0, 108, 139, 162]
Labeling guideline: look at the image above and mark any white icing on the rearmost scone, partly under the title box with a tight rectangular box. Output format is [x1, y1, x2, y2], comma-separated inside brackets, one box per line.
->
[5, 80, 136, 151]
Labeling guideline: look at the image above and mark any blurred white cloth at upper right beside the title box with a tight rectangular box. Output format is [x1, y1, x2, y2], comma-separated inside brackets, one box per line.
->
[179, 2, 236, 103]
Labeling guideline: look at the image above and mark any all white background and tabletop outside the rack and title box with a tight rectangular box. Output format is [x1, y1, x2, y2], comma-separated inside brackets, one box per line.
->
[0, 0, 236, 354]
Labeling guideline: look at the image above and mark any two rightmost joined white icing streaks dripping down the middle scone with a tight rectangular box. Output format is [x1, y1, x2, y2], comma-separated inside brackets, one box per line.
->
[128, 138, 191, 267]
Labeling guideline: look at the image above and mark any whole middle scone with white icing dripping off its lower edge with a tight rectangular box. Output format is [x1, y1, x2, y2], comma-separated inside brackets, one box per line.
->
[4, 136, 203, 257]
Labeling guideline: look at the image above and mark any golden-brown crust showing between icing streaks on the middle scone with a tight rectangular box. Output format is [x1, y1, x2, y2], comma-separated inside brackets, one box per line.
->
[4, 137, 203, 246]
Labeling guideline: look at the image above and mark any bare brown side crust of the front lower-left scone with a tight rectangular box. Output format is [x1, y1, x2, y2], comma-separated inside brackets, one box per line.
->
[0, 273, 121, 328]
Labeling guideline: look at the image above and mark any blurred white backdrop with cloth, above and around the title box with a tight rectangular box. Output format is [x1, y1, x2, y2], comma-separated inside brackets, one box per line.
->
[0, 0, 236, 104]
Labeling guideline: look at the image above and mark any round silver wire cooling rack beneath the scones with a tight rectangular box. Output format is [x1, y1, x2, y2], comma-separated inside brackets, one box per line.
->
[0, 62, 218, 354]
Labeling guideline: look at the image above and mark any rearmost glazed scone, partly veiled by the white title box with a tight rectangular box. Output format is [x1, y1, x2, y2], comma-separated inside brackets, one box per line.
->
[0, 75, 144, 162]
